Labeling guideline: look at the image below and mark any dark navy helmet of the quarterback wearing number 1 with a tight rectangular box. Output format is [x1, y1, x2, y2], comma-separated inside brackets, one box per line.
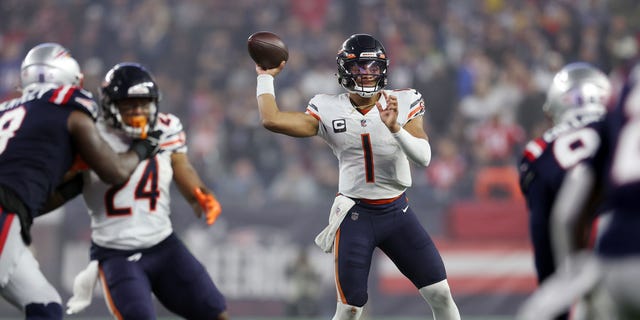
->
[336, 34, 389, 98]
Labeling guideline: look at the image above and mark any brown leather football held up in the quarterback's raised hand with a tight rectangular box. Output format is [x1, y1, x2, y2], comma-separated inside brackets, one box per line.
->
[247, 31, 289, 70]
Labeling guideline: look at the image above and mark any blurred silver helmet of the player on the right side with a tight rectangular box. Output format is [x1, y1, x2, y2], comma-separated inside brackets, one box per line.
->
[542, 62, 611, 124]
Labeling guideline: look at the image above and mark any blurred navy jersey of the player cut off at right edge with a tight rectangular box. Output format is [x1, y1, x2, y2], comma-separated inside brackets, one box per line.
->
[586, 85, 640, 257]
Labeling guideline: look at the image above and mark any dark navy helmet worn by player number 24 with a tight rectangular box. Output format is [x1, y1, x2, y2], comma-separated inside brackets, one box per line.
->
[100, 62, 160, 138]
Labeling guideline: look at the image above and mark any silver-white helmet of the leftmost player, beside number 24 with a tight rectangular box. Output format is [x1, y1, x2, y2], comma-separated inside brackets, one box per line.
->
[20, 42, 84, 88]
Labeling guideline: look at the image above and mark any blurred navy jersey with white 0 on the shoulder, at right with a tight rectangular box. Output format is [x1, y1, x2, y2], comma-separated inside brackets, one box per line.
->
[519, 119, 600, 282]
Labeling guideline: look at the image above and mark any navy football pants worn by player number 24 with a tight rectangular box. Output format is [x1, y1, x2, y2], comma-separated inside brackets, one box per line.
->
[92, 234, 226, 319]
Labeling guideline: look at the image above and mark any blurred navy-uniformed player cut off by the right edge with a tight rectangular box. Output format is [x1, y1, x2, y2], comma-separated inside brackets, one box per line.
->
[552, 66, 640, 319]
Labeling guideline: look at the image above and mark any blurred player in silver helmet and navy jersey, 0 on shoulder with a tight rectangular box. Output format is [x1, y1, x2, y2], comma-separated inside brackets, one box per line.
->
[519, 62, 611, 318]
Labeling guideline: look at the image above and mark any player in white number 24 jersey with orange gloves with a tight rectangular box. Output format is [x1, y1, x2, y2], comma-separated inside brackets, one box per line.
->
[57, 63, 227, 320]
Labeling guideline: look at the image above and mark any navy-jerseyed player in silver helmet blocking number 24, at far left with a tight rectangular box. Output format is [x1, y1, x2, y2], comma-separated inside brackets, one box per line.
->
[0, 43, 159, 319]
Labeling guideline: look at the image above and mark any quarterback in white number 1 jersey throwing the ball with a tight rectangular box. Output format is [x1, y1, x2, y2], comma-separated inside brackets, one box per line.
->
[256, 34, 460, 320]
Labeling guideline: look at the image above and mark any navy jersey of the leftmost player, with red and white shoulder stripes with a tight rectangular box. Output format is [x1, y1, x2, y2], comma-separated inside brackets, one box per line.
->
[0, 86, 98, 217]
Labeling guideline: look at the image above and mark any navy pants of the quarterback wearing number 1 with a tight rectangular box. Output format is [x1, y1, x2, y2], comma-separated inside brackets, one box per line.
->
[334, 195, 447, 307]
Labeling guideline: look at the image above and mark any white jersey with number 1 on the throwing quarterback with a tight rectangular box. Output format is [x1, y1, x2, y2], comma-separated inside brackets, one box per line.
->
[306, 89, 424, 199]
